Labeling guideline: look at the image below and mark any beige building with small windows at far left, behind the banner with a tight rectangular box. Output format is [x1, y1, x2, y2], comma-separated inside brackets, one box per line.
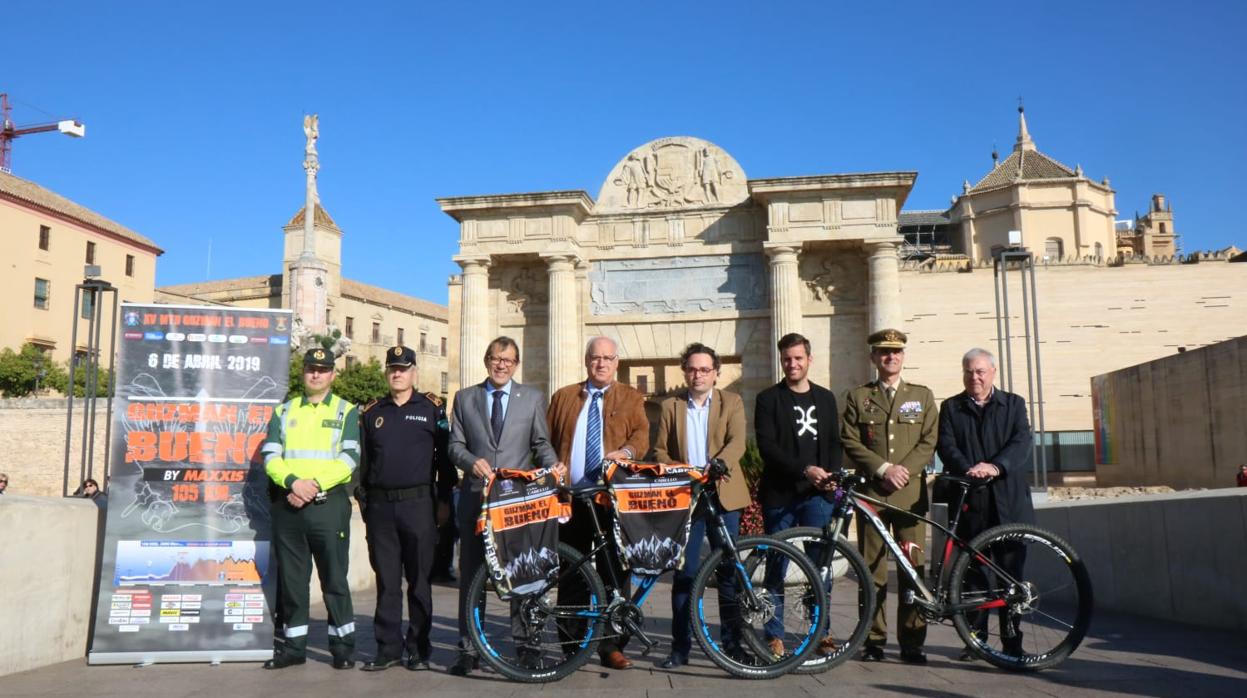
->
[0, 172, 162, 361]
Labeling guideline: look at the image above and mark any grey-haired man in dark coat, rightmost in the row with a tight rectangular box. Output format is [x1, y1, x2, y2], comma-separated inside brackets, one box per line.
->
[936, 349, 1035, 659]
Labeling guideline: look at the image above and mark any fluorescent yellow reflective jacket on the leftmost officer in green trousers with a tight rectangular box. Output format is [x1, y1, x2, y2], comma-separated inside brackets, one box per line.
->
[261, 393, 359, 491]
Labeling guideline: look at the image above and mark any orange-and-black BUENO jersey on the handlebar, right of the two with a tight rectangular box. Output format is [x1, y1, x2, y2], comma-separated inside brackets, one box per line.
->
[604, 460, 702, 575]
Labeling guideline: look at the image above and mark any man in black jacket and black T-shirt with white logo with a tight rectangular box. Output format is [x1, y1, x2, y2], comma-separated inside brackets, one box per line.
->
[753, 333, 843, 654]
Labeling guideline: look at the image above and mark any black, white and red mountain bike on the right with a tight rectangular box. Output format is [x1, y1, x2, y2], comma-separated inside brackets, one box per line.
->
[777, 470, 1094, 673]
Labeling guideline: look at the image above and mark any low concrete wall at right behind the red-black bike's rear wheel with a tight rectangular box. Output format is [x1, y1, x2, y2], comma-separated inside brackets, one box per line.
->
[1036, 487, 1247, 631]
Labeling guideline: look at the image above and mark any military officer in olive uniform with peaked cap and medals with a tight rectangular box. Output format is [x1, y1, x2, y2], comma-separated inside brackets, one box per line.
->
[840, 329, 939, 664]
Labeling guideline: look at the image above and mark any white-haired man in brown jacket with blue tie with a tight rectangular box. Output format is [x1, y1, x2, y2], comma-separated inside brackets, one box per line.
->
[546, 337, 650, 669]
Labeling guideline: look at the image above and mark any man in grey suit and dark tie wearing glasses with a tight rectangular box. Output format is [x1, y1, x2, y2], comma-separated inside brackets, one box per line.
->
[449, 337, 560, 676]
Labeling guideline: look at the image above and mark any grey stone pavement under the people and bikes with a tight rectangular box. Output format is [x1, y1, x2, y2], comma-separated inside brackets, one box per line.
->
[0, 575, 1247, 698]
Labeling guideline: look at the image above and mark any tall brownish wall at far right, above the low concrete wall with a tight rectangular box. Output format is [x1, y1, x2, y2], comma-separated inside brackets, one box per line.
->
[1091, 336, 1247, 489]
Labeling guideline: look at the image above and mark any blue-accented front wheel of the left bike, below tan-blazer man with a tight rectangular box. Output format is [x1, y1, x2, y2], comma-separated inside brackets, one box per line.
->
[690, 536, 827, 678]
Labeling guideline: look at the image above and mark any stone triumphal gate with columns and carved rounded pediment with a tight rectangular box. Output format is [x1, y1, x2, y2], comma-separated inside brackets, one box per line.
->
[438, 137, 915, 411]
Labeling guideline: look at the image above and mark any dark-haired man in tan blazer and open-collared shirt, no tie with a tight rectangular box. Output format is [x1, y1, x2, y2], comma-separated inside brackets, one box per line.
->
[653, 343, 749, 669]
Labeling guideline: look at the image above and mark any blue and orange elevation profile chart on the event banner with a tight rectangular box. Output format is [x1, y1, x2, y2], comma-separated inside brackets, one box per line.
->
[112, 541, 268, 586]
